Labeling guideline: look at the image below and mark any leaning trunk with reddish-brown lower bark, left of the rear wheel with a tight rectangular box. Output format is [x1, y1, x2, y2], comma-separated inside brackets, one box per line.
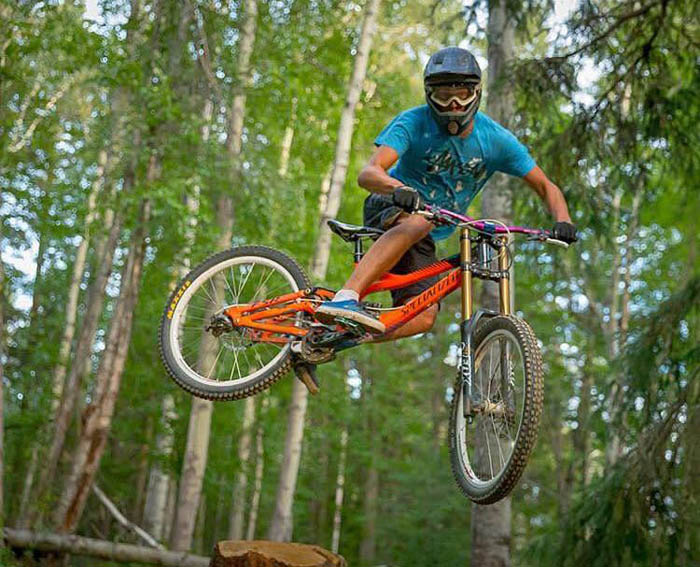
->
[53, 197, 152, 533]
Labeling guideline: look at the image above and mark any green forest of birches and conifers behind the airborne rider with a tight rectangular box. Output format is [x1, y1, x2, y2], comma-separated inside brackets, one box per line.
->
[0, 0, 700, 567]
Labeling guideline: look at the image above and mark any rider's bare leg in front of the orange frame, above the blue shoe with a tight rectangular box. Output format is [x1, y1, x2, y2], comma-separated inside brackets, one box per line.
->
[343, 213, 435, 294]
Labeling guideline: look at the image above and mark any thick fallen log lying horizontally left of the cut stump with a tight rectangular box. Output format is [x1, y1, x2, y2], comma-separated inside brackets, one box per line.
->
[3, 528, 209, 567]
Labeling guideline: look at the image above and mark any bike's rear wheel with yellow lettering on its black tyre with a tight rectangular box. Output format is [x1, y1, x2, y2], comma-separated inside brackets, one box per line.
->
[159, 246, 309, 400]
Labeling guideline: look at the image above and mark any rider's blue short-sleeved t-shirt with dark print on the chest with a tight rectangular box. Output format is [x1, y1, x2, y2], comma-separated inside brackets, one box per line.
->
[374, 105, 535, 240]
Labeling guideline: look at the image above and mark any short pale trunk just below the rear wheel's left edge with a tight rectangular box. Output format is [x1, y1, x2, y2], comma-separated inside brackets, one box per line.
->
[143, 394, 177, 541]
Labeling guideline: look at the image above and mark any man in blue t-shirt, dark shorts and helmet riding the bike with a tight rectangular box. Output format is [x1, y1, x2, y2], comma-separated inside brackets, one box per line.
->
[316, 47, 576, 340]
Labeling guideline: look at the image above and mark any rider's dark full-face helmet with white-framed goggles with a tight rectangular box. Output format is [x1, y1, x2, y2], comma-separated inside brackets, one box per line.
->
[423, 47, 481, 136]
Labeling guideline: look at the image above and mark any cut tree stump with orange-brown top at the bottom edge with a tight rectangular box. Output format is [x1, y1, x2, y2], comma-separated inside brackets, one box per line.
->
[209, 541, 347, 567]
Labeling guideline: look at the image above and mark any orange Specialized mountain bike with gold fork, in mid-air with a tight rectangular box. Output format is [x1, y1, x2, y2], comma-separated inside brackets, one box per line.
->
[160, 205, 567, 504]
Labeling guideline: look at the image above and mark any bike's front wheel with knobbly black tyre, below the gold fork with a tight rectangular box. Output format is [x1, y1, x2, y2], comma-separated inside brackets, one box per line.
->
[449, 315, 544, 504]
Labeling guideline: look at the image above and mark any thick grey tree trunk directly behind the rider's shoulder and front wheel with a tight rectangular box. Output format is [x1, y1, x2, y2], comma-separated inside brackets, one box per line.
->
[471, 0, 515, 567]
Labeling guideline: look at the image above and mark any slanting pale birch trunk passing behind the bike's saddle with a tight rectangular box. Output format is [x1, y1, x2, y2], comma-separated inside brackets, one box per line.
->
[268, 0, 380, 541]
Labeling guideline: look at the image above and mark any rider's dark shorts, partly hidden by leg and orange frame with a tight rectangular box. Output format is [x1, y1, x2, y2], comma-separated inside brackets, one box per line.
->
[363, 193, 440, 306]
